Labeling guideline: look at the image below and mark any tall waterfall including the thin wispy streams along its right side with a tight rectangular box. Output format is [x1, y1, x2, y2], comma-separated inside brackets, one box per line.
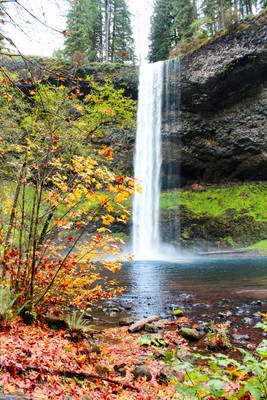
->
[133, 60, 179, 260]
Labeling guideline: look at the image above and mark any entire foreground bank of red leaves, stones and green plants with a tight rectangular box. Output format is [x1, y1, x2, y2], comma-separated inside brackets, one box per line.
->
[0, 310, 267, 400]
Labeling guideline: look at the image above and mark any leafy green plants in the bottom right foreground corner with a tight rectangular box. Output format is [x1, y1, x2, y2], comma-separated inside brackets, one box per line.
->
[162, 341, 267, 400]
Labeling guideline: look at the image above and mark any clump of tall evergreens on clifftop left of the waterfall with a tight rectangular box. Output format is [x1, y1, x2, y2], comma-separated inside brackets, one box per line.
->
[65, 0, 134, 62]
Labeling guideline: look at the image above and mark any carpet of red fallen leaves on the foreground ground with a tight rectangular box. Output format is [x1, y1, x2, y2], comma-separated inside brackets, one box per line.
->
[0, 320, 182, 400]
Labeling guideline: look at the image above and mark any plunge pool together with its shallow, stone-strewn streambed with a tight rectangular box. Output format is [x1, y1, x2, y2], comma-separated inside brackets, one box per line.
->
[88, 257, 267, 347]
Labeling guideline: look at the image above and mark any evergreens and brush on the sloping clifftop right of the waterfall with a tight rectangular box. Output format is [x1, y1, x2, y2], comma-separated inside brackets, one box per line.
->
[149, 0, 264, 62]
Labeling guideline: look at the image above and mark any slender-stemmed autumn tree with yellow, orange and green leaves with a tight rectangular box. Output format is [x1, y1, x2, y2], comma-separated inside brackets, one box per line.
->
[0, 70, 135, 312]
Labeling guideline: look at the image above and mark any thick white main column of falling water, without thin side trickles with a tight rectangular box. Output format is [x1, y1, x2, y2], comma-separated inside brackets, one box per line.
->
[133, 62, 164, 259]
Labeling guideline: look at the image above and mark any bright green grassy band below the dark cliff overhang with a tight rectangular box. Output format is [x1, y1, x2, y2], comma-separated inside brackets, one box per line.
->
[161, 182, 267, 222]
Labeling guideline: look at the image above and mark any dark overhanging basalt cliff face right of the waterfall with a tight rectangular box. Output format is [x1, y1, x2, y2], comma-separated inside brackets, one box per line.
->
[163, 12, 267, 187]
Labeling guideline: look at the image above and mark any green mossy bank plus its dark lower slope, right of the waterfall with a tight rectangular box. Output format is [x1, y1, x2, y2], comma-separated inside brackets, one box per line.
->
[161, 183, 267, 250]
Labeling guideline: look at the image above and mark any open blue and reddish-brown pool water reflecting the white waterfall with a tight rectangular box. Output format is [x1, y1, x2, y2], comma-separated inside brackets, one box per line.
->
[94, 257, 267, 319]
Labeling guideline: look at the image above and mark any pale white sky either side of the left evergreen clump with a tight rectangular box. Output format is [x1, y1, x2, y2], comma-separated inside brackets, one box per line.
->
[2, 0, 153, 59]
